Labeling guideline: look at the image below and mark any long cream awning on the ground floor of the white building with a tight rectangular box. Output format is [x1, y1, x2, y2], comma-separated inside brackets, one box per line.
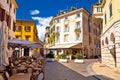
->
[47, 43, 82, 49]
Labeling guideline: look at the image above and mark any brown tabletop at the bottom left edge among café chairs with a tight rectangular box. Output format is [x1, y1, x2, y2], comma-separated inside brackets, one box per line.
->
[8, 73, 31, 80]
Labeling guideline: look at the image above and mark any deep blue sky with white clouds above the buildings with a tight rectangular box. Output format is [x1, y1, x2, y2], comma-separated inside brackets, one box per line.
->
[16, 0, 98, 40]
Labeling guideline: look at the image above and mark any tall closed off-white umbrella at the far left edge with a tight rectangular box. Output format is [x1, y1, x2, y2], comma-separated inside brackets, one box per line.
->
[0, 21, 9, 65]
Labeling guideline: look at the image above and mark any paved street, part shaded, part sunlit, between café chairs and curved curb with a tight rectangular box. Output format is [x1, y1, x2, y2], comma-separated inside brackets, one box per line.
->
[46, 60, 98, 80]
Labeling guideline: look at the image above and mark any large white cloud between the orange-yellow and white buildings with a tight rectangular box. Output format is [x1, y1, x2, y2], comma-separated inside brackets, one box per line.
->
[32, 16, 53, 41]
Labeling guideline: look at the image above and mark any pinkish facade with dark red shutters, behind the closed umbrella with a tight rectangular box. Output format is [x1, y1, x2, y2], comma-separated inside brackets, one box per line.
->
[0, 0, 18, 39]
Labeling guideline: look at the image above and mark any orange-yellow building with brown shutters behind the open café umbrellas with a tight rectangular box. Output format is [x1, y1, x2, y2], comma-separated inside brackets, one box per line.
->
[15, 20, 43, 56]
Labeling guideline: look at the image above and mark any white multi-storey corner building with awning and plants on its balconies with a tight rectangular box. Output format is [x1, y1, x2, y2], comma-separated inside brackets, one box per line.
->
[48, 8, 100, 58]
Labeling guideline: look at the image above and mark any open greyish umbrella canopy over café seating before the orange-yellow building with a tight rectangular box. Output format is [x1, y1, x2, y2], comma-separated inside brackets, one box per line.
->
[8, 39, 42, 48]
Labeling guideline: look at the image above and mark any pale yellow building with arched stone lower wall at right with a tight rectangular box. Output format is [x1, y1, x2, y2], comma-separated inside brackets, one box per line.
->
[92, 0, 120, 69]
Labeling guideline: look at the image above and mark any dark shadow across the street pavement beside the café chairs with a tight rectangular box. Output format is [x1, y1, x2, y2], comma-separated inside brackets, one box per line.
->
[45, 61, 113, 80]
